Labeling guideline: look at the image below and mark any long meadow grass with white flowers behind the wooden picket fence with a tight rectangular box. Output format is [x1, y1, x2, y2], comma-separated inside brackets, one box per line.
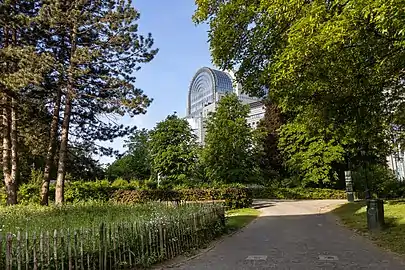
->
[0, 202, 221, 233]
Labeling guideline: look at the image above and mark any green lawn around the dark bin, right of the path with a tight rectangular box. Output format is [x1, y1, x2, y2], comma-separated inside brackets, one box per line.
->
[333, 201, 405, 254]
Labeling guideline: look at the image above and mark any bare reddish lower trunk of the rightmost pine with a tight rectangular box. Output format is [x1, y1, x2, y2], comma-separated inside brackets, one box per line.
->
[55, 90, 72, 204]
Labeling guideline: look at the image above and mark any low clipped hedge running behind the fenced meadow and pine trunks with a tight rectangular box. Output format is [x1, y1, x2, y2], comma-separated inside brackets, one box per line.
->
[13, 180, 253, 208]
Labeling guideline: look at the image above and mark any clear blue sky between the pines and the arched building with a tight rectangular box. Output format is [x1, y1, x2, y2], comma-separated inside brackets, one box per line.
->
[100, 0, 212, 163]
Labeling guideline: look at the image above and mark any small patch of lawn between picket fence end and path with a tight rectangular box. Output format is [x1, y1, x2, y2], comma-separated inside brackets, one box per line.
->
[226, 208, 260, 231]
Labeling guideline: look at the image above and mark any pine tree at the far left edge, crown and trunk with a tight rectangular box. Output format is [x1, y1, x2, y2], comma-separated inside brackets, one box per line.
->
[0, 0, 48, 205]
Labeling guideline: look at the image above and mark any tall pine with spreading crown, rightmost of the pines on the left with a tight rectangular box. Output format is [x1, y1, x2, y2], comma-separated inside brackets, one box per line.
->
[36, 0, 157, 204]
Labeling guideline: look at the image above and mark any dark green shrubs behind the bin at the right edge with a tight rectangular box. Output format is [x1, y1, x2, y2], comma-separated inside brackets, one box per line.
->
[352, 164, 405, 199]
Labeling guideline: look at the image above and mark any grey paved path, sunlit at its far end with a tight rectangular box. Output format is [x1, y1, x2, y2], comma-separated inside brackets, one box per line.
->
[167, 200, 405, 270]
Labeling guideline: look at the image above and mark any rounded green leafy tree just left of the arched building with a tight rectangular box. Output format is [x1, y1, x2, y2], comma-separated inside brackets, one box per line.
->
[149, 114, 197, 183]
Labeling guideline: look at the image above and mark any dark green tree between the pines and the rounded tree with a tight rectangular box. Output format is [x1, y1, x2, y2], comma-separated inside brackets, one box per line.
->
[107, 129, 151, 180]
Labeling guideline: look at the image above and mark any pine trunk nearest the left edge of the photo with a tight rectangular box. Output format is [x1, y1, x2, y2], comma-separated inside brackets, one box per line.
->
[3, 95, 17, 205]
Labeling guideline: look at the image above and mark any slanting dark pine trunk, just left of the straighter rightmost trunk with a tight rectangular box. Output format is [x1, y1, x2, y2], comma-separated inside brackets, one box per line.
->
[41, 88, 62, 205]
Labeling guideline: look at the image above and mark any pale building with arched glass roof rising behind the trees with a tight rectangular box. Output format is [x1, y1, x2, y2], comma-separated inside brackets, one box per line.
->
[186, 67, 265, 144]
